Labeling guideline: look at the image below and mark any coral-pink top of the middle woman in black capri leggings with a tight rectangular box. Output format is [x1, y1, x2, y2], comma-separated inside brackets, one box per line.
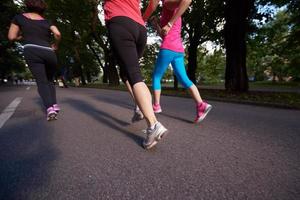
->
[104, 0, 145, 26]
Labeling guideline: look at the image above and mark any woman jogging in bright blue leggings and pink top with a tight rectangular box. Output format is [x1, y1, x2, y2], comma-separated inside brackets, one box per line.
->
[143, 0, 212, 123]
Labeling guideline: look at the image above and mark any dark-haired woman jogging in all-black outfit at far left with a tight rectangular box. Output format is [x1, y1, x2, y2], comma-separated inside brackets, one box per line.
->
[8, 0, 61, 121]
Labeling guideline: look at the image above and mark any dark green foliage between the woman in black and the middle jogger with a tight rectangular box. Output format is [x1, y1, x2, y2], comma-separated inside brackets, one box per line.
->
[47, 0, 101, 81]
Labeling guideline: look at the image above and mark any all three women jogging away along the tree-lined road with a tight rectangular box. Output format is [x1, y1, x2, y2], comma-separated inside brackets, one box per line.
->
[8, 0, 212, 149]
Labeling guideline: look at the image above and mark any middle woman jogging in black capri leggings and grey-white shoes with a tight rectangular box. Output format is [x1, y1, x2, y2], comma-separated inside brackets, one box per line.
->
[104, 0, 167, 149]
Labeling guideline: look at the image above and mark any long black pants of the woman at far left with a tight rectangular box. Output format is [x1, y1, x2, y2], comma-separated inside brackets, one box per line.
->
[24, 47, 57, 108]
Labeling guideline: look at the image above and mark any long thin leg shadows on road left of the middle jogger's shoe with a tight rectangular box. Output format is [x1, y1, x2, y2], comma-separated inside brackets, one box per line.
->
[64, 99, 143, 145]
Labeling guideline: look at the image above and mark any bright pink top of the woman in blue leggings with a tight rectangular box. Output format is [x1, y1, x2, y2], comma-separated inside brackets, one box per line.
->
[160, 0, 184, 53]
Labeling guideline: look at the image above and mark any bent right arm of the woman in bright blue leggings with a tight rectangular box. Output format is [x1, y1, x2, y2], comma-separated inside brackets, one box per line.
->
[162, 0, 192, 35]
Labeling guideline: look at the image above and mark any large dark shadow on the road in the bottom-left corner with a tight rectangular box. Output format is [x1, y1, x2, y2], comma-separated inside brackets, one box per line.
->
[0, 120, 58, 200]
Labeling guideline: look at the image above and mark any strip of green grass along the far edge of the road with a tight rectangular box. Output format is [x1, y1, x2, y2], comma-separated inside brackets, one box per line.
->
[77, 84, 300, 109]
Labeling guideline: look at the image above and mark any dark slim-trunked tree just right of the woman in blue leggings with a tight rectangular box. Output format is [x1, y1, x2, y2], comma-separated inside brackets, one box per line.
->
[183, 0, 224, 84]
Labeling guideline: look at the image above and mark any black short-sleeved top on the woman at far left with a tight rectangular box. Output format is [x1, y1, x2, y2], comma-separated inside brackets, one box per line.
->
[12, 14, 53, 47]
